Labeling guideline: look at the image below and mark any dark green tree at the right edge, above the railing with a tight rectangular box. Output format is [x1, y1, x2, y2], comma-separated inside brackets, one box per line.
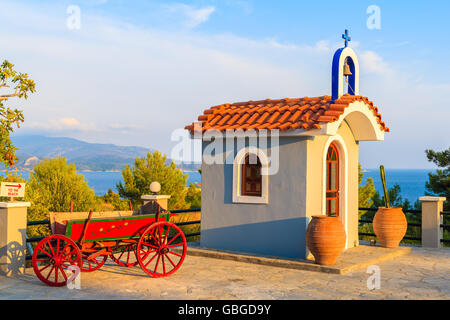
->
[425, 148, 450, 211]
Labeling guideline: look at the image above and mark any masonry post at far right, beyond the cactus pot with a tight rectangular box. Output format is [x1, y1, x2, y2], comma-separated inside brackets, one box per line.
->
[419, 197, 446, 248]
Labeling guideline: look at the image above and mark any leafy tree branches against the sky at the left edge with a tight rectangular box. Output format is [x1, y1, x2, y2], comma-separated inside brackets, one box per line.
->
[0, 60, 35, 167]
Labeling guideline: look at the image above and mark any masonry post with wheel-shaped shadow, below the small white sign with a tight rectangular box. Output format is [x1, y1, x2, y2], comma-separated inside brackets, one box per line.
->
[0, 202, 30, 276]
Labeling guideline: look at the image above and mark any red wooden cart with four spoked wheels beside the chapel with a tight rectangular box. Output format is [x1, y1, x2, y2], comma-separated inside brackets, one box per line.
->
[32, 208, 186, 287]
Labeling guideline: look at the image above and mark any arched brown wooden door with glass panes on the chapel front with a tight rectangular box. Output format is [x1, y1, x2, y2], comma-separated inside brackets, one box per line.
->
[326, 142, 340, 217]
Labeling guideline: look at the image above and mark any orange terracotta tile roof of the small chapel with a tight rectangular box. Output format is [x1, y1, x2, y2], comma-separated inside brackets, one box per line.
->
[185, 94, 389, 134]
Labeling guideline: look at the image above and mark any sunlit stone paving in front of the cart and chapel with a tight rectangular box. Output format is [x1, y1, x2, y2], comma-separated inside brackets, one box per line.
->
[0, 248, 450, 300]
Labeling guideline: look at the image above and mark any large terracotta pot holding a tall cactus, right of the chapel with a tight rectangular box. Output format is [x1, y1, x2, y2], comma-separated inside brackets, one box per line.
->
[373, 207, 408, 248]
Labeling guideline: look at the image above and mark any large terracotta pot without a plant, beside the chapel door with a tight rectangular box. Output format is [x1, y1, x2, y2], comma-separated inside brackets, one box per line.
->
[306, 216, 347, 265]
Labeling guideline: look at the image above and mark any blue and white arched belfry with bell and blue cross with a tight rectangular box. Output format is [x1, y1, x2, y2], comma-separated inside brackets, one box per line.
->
[331, 30, 359, 102]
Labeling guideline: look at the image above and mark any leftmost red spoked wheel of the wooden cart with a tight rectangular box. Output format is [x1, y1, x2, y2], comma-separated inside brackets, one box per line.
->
[32, 234, 81, 287]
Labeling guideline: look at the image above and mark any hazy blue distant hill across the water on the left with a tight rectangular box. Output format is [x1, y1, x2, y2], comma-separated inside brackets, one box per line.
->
[6, 135, 200, 171]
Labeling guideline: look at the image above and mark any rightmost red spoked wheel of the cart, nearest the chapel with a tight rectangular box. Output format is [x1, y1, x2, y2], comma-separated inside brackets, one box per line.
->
[137, 221, 187, 277]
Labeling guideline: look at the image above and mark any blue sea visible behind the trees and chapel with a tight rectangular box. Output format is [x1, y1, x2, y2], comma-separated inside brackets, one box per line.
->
[6, 169, 434, 203]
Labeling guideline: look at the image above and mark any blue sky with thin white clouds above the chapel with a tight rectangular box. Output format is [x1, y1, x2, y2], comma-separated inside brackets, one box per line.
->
[0, 0, 450, 168]
